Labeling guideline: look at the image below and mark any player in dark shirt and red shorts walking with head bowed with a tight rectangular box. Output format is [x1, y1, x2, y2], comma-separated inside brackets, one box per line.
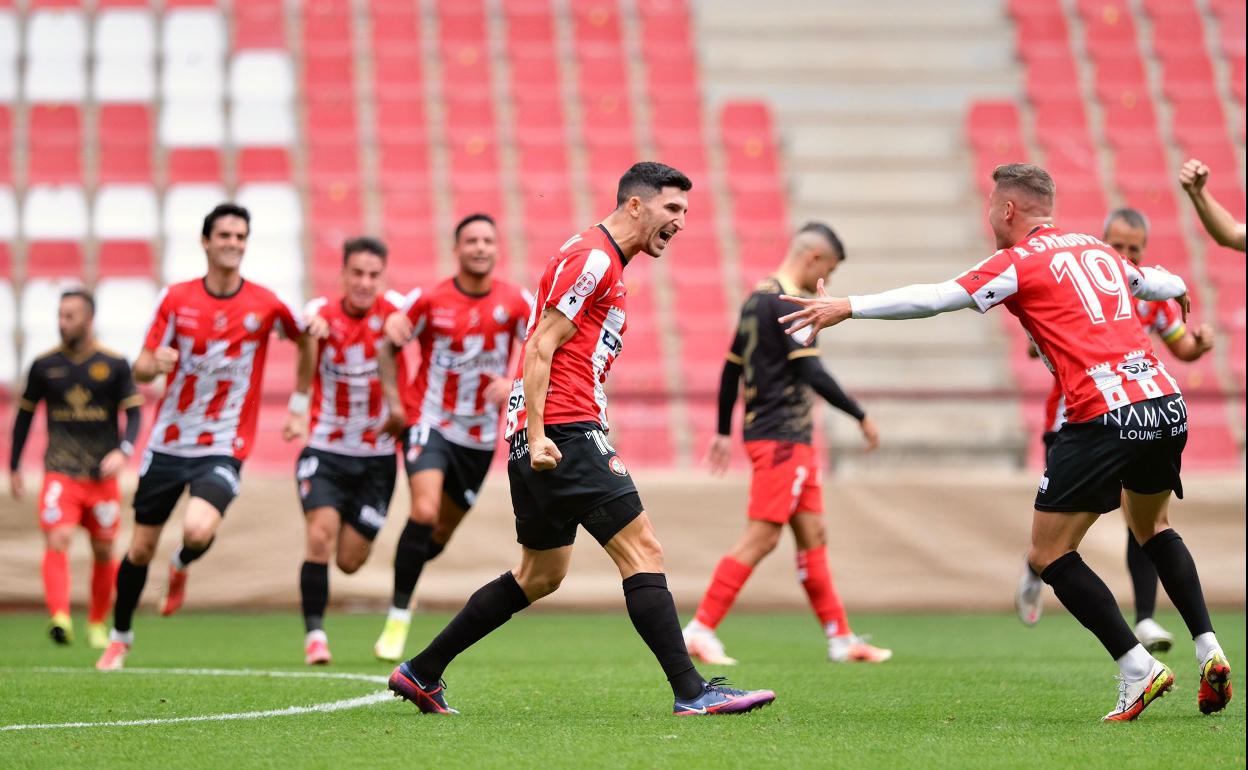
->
[685, 222, 892, 665]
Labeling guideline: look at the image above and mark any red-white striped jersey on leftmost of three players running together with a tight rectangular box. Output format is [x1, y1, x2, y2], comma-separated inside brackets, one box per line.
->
[144, 278, 303, 459]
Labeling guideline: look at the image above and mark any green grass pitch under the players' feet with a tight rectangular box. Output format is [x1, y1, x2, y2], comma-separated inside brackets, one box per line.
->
[0, 612, 1246, 770]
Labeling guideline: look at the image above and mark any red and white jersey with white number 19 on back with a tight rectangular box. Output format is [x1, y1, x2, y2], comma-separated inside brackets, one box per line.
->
[956, 226, 1179, 422]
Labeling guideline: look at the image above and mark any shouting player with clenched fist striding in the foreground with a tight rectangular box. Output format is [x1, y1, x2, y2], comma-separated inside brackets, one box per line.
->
[389, 162, 775, 715]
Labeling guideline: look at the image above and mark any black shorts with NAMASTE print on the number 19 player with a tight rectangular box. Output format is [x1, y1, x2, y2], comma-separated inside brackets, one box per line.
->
[1036, 394, 1187, 513]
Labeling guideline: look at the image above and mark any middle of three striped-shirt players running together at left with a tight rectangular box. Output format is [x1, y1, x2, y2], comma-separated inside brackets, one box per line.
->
[295, 237, 403, 665]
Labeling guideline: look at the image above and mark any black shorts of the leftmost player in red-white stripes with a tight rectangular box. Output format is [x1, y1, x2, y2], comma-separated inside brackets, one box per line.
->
[135, 449, 242, 527]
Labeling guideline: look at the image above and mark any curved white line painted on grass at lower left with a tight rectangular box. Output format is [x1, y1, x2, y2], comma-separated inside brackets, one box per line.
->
[0, 668, 391, 731]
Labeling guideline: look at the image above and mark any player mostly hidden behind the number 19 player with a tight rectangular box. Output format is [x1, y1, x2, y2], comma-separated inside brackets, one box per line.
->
[1015, 208, 1213, 653]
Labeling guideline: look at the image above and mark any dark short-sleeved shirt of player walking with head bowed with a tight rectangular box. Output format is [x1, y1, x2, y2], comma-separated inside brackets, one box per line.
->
[728, 276, 819, 444]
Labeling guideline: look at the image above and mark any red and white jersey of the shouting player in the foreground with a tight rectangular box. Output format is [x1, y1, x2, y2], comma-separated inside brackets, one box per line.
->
[507, 225, 628, 438]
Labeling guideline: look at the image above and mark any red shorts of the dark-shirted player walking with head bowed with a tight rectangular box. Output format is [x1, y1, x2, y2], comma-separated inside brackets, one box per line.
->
[745, 441, 824, 524]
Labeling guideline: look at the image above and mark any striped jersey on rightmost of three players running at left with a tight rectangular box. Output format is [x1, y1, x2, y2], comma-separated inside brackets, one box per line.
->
[401, 277, 533, 449]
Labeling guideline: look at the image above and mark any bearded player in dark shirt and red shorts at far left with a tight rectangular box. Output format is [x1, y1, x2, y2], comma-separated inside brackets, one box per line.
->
[9, 290, 144, 649]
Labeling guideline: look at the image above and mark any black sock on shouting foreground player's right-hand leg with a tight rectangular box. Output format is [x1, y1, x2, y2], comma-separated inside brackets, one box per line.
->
[624, 572, 704, 699]
